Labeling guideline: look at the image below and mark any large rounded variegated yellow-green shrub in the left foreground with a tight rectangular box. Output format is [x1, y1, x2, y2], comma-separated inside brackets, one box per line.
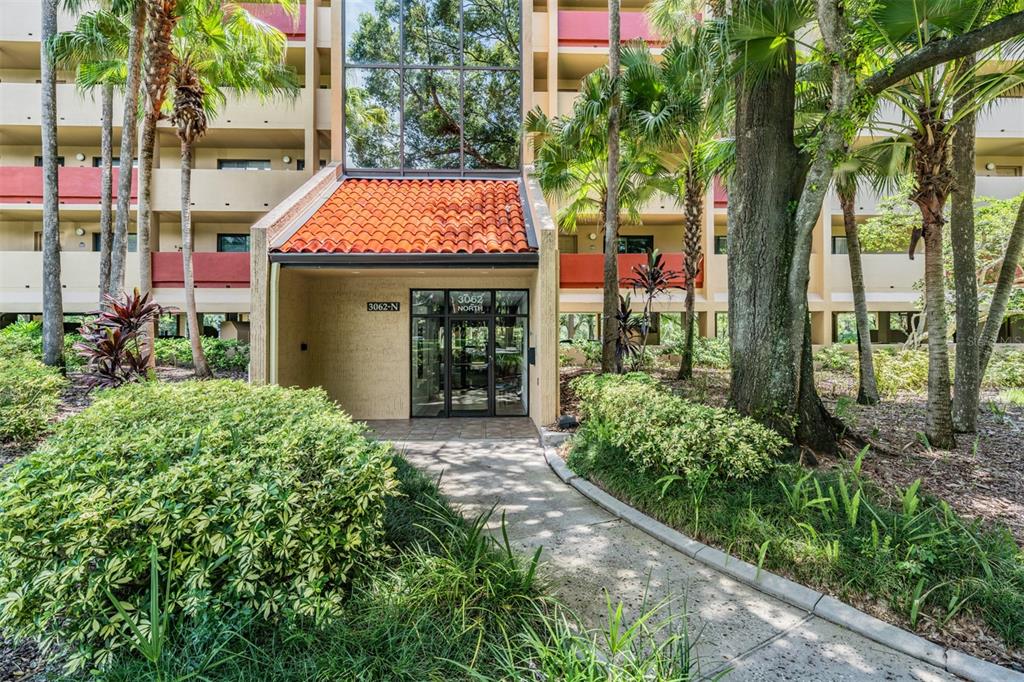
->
[0, 381, 395, 669]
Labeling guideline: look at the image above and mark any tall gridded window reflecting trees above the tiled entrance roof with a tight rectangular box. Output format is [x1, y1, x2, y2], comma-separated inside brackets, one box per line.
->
[342, 0, 522, 173]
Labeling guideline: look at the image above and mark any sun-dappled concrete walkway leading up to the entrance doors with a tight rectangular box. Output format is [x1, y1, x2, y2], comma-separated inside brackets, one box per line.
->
[381, 429, 958, 681]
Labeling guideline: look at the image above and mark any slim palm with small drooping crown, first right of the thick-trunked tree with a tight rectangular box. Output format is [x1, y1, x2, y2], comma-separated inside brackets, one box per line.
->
[833, 140, 909, 404]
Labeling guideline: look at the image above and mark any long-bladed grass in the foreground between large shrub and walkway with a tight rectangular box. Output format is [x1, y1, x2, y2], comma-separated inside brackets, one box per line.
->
[97, 450, 720, 682]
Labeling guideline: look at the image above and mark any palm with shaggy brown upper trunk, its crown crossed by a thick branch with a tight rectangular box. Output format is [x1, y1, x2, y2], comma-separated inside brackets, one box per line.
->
[863, 0, 1024, 450]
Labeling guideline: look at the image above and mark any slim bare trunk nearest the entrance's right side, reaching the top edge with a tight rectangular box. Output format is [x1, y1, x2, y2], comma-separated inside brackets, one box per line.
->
[601, 0, 622, 373]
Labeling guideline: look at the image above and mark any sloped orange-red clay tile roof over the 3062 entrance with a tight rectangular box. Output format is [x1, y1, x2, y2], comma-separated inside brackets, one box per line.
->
[269, 178, 538, 267]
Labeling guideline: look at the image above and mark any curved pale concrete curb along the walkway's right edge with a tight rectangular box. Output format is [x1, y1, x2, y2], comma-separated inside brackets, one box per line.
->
[541, 438, 1024, 682]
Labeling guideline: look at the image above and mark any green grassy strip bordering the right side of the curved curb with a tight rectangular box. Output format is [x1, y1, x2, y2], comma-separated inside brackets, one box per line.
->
[568, 424, 1024, 647]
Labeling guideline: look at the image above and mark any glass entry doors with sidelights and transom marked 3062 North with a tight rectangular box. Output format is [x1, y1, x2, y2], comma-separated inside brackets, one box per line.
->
[410, 289, 529, 417]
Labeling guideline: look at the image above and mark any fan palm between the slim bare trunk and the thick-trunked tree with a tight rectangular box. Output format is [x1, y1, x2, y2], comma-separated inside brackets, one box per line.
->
[624, 33, 734, 379]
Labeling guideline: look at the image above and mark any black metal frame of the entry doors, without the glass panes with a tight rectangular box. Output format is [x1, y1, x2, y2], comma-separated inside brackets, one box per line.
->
[409, 287, 532, 419]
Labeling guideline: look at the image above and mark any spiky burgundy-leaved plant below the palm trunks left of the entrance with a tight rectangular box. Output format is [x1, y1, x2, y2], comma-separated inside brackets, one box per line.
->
[75, 289, 163, 388]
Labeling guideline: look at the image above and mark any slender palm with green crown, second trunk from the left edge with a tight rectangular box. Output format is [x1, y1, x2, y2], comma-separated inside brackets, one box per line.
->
[51, 2, 130, 306]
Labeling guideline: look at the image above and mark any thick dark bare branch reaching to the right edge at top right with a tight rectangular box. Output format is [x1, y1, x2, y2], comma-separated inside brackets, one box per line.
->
[862, 11, 1024, 95]
